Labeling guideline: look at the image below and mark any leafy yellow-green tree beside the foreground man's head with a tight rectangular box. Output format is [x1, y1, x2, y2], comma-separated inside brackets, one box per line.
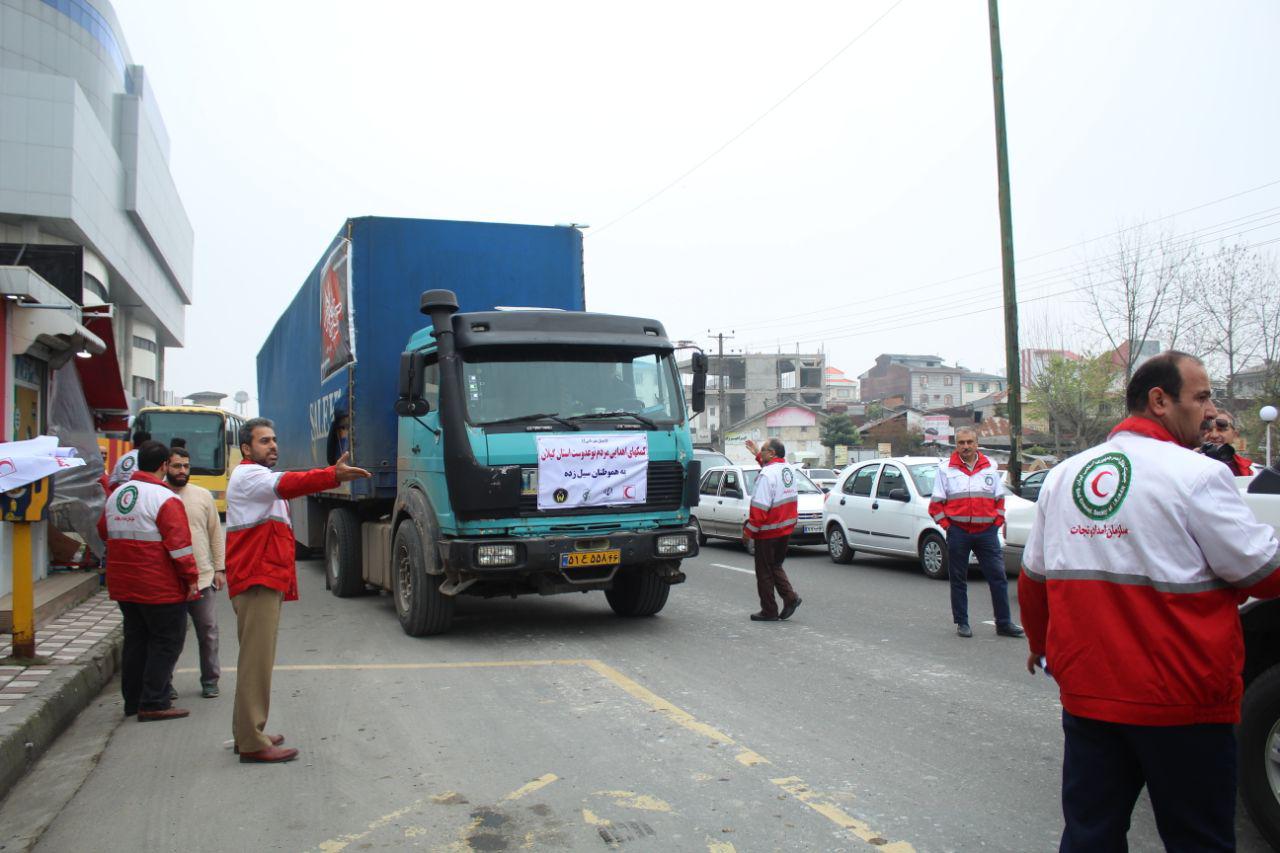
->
[1027, 355, 1120, 456]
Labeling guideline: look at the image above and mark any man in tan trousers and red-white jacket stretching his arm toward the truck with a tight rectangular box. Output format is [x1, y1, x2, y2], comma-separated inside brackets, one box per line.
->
[227, 418, 370, 763]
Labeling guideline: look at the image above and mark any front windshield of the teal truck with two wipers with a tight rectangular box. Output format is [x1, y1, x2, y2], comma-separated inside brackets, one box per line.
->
[462, 347, 684, 428]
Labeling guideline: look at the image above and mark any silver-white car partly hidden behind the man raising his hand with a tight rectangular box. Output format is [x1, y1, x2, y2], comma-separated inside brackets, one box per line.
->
[691, 465, 823, 553]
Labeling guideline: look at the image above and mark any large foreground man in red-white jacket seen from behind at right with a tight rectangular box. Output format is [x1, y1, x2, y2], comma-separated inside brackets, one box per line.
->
[1018, 351, 1280, 852]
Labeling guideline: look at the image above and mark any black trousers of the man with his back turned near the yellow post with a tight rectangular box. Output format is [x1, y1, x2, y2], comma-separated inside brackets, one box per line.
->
[116, 601, 187, 716]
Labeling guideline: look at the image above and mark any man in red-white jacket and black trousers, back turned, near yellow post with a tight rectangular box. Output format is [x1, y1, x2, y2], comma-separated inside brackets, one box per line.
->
[97, 441, 200, 722]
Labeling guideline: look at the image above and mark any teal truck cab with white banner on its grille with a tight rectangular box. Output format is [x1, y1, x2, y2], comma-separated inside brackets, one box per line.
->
[350, 291, 707, 635]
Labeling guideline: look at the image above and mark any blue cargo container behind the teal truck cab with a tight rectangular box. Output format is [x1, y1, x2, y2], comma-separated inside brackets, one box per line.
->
[257, 216, 585, 500]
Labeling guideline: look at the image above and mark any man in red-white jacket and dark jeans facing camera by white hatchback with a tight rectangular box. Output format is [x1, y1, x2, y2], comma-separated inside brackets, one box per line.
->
[929, 427, 1023, 638]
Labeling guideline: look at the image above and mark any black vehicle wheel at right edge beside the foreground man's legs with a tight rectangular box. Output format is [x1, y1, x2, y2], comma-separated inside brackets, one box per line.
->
[1236, 666, 1280, 849]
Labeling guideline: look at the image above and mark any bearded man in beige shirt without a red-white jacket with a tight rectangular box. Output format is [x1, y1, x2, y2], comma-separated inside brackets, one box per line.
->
[168, 447, 227, 699]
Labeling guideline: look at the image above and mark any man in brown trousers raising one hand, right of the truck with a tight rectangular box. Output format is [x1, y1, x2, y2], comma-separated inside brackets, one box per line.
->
[742, 438, 800, 622]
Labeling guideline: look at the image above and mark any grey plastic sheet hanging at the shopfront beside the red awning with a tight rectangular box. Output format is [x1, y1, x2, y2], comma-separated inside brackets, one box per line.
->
[49, 364, 106, 557]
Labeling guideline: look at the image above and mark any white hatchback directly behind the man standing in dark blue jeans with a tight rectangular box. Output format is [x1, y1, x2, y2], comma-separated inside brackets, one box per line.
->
[822, 456, 1034, 580]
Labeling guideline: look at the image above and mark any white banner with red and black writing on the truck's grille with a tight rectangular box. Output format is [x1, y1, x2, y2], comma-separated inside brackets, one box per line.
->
[538, 433, 649, 510]
